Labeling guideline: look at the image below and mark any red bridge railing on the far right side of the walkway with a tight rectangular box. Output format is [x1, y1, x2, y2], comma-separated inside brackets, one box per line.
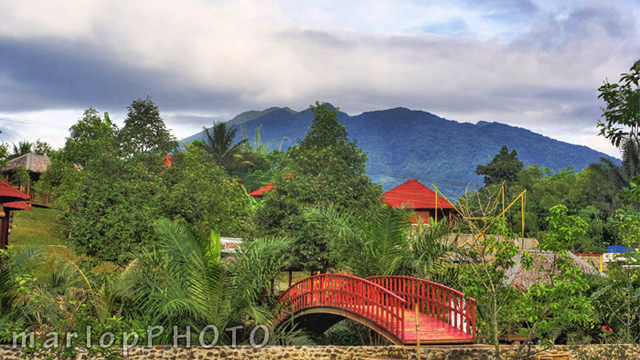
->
[367, 276, 476, 338]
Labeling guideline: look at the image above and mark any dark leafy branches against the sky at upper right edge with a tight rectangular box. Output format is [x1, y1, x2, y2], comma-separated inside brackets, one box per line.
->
[597, 60, 640, 147]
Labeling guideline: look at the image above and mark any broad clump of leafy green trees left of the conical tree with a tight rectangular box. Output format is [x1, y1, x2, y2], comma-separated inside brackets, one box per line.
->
[38, 99, 248, 262]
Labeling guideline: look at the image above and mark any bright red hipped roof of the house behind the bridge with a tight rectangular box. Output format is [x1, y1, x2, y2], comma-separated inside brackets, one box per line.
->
[382, 180, 453, 209]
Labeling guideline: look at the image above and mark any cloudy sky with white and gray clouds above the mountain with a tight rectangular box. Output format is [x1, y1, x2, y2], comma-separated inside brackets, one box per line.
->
[0, 0, 640, 155]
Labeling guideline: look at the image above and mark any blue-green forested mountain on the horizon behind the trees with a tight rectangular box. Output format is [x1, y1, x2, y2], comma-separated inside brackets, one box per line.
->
[182, 108, 619, 194]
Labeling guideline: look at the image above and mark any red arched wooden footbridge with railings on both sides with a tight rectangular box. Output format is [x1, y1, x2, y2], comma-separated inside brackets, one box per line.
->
[275, 274, 476, 345]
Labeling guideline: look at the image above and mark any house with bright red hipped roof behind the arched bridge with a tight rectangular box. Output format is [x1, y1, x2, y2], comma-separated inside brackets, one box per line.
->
[382, 180, 455, 224]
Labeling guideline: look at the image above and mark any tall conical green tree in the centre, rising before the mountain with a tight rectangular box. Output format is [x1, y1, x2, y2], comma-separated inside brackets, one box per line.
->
[256, 103, 382, 271]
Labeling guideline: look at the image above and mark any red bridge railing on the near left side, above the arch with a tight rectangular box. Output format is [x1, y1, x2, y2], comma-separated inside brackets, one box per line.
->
[279, 274, 407, 339]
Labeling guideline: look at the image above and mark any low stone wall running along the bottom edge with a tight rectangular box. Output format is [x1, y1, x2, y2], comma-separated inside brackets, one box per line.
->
[0, 345, 640, 360]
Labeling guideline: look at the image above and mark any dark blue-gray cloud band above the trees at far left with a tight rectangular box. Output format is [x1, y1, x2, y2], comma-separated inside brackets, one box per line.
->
[0, 38, 248, 112]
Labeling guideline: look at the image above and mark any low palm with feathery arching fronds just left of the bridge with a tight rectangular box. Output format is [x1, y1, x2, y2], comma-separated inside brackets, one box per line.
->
[117, 220, 289, 343]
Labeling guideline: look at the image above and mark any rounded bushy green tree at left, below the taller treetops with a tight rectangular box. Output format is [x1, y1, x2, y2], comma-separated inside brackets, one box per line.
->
[60, 152, 169, 263]
